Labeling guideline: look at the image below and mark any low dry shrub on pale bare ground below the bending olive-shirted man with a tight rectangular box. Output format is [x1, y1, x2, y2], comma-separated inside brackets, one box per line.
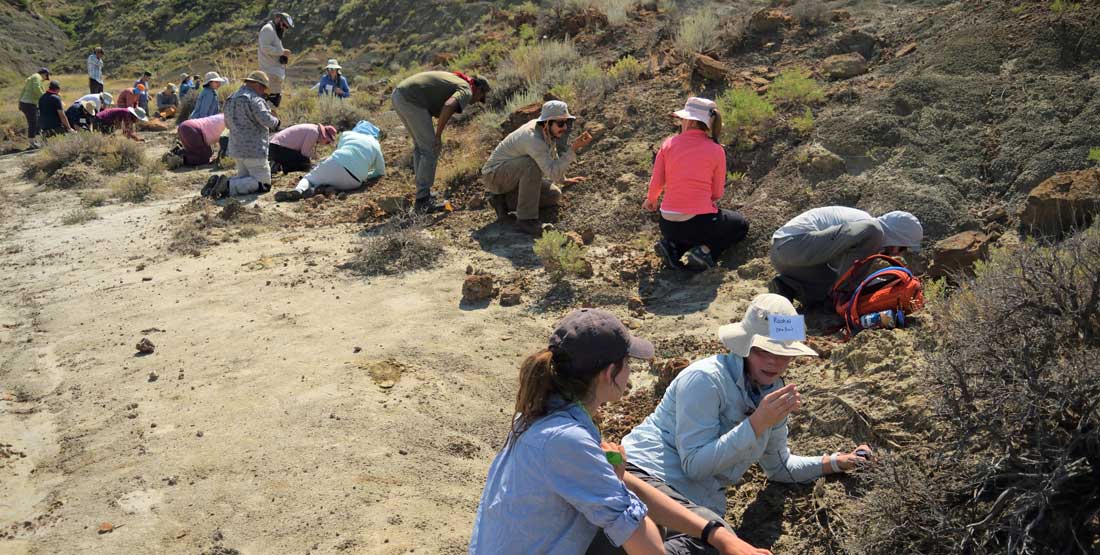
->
[340, 212, 444, 276]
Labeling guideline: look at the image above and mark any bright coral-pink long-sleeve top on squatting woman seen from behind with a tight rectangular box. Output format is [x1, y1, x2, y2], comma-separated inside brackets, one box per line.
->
[647, 129, 726, 214]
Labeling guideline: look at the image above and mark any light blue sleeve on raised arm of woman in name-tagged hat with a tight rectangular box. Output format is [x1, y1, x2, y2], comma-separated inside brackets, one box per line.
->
[675, 371, 756, 480]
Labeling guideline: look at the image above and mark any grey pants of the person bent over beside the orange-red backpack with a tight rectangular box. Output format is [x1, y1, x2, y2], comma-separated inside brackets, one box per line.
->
[771, 220, 882, 307]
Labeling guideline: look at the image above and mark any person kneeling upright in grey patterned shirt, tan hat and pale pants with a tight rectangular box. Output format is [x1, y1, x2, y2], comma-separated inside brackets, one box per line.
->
[202, 71, 279, 199]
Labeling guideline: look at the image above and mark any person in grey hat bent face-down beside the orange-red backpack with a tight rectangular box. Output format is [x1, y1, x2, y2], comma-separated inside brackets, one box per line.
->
[769, 207, 924, 308]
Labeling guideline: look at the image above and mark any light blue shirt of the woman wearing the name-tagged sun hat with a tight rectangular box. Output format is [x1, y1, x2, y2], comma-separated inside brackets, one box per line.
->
[623, 354, 822, 514]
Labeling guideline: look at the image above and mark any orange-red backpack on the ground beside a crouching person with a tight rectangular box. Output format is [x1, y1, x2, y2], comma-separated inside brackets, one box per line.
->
[832, 254, 924, 333]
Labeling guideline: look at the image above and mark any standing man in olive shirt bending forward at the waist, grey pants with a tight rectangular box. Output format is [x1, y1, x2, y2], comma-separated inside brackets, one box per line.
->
[391, 71, 490, 213]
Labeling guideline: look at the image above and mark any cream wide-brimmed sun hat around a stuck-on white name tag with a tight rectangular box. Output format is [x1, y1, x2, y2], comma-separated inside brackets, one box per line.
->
[718, 293, 817, 357]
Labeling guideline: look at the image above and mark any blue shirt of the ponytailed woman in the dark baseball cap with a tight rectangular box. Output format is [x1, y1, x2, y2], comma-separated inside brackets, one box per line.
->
[470, 398, 647, 555]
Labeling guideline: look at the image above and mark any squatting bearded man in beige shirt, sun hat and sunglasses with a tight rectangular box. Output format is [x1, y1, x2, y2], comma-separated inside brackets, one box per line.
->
[482, 100, 592, 236]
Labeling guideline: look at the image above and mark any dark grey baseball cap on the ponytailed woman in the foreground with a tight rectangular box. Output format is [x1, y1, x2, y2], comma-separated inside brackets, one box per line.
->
[550, 309, 653, 375]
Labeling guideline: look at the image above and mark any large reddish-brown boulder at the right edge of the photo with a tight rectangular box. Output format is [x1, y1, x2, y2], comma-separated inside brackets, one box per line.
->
[1020, 168, 1100, 235]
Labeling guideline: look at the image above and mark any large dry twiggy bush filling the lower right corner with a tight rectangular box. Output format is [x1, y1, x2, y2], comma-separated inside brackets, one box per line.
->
[848, 227, 1100, 555]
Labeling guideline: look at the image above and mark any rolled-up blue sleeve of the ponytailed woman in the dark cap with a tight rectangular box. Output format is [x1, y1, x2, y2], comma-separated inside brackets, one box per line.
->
[546, 428, 648, 546]
